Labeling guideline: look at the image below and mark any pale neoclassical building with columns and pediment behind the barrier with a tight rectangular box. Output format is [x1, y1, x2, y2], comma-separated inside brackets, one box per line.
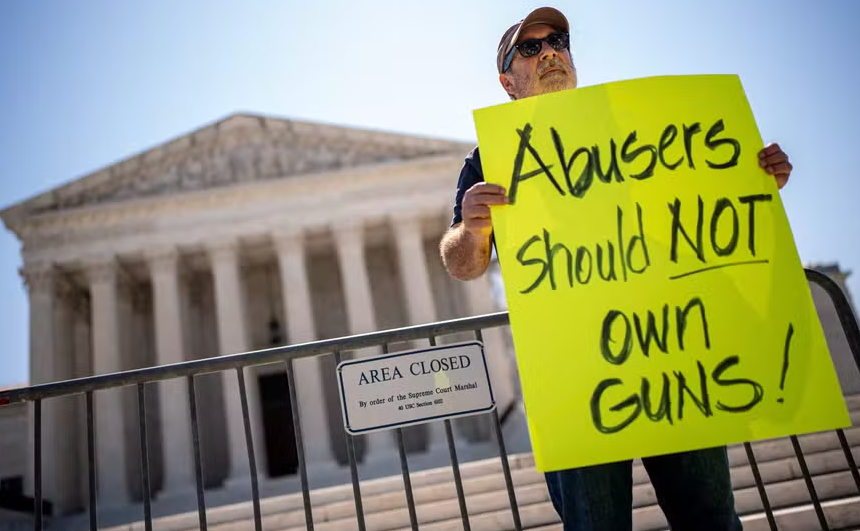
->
[0, 114, 516, 513]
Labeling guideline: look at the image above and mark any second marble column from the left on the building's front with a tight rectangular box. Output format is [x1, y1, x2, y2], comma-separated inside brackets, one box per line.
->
[87, 260, 130, 506]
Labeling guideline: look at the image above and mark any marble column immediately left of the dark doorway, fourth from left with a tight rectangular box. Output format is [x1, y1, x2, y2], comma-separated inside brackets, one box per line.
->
[208, 240, 266, 487]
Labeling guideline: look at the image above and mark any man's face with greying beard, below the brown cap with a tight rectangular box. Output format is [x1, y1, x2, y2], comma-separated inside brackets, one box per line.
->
[499, 24, 576, 100]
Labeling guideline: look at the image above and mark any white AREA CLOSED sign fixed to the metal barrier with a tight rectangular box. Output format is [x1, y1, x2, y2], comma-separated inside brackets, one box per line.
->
[337, 341, 495, 435]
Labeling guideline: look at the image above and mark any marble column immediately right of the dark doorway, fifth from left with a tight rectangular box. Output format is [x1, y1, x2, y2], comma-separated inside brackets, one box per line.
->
[272, 230, 334, 464]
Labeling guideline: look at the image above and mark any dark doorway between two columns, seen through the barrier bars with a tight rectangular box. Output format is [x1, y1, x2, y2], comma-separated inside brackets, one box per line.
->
[259, 372, 299, 478]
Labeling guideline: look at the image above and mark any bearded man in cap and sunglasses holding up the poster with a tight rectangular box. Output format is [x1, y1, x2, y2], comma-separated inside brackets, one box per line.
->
[440, 7, 792, 531]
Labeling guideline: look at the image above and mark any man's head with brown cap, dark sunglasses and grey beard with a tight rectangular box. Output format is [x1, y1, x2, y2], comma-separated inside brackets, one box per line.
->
[496, 7, 577, 100]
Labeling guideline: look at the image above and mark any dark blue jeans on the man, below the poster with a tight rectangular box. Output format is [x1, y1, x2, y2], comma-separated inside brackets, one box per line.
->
[546, 447, 743, 531]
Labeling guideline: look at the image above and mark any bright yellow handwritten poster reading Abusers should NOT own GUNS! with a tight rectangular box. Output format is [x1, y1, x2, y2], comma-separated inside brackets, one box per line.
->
[474, 75, 850, 471]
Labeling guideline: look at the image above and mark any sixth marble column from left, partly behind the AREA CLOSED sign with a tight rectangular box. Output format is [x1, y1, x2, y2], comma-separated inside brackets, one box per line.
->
[332, 222, 397, 462]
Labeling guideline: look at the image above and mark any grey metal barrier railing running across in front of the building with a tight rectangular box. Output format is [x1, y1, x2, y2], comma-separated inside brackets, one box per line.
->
[0, 269, 860, 531]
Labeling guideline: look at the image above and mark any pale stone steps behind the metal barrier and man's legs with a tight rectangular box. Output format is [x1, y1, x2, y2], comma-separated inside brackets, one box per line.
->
[72, 395, 860, 531]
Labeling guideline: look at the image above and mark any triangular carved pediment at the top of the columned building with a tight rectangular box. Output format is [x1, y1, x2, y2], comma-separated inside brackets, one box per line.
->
[9, 114, 471, 220]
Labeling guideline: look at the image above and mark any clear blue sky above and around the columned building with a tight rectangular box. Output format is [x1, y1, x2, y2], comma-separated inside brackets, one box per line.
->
[0, 0, 860, 386]
